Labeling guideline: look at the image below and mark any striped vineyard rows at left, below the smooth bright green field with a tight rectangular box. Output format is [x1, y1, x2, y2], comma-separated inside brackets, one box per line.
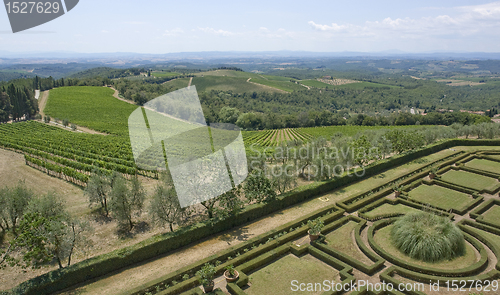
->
[0, 121, 147, 185]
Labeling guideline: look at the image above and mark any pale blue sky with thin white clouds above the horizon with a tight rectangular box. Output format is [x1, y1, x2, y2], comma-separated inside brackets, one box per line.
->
[0, 0, 500, 54]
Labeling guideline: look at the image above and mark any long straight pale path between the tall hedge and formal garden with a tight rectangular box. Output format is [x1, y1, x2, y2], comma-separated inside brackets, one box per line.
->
[54, 150, 476, 294]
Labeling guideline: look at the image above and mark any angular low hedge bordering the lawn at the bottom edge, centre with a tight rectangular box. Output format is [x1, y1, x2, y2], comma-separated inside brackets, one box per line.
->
[227, 244, 355, 295]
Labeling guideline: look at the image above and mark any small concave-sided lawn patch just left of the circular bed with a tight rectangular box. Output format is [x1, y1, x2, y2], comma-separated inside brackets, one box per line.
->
[326, 221, 373, 264]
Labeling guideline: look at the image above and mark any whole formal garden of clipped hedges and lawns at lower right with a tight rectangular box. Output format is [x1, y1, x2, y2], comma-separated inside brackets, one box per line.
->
[115, 150, 500, 295]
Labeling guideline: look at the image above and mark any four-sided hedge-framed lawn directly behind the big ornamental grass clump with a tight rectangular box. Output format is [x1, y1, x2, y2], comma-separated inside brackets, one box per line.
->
[408, 184, 472, 210]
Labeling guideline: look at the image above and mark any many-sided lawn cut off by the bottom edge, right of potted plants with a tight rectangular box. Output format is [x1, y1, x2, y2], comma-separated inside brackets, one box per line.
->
[245, 254, 339, 295]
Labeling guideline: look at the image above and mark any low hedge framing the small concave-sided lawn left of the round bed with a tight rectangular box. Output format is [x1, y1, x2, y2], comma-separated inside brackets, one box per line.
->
[311, 215, 385, 275]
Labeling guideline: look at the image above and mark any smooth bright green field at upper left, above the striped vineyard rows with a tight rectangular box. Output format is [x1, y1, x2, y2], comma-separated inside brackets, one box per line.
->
[45, 86, 137, 135]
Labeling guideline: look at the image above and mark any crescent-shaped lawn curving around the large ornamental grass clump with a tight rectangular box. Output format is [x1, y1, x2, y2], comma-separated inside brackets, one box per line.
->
[375, 225, 477, 270]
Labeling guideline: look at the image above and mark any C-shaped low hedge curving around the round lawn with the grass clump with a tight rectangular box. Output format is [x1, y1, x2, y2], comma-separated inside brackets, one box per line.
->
[368, 218, 488, 277]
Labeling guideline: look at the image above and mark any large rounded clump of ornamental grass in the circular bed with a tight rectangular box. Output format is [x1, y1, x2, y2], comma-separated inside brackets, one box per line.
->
[391, 212, 466, 262]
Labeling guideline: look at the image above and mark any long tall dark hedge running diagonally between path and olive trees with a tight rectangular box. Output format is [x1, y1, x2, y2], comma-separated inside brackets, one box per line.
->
[4, 139, 500, 295]
